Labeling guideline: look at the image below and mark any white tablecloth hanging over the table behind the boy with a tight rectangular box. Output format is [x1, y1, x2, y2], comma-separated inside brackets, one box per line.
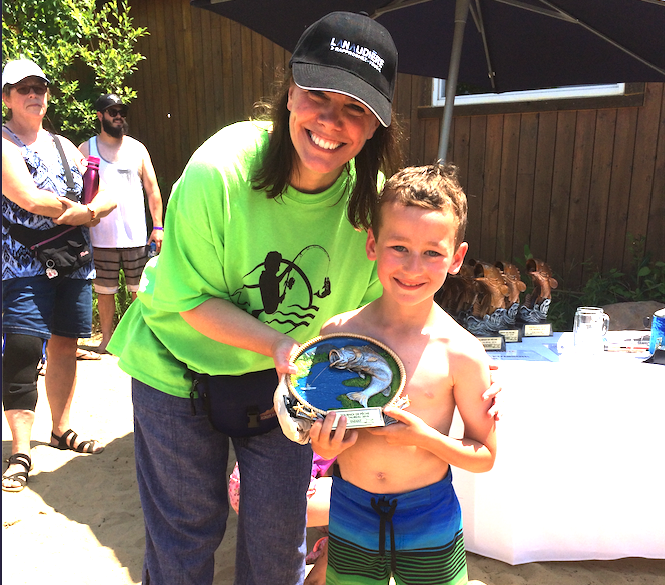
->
[451, 338, 665, 565]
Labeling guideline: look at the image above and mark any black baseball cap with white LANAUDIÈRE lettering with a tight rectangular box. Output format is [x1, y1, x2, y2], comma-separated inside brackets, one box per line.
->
[290, 12, 397, 126]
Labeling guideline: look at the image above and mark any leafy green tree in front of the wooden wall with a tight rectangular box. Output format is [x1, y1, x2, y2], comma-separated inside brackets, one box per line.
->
[2, 0, 149, 144]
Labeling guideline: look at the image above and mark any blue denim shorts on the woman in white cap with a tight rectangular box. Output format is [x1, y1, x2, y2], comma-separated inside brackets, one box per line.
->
[2, 274, 92, 339]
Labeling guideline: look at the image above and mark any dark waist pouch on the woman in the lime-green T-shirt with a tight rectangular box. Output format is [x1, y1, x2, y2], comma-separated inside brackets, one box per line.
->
[193, 370, 279, 437]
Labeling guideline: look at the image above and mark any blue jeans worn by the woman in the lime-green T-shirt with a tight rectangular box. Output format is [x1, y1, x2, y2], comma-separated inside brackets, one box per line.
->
[132, 379, 312, 585]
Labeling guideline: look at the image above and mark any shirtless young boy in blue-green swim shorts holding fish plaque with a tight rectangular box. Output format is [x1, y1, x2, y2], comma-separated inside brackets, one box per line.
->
[310, 164, 496, 585]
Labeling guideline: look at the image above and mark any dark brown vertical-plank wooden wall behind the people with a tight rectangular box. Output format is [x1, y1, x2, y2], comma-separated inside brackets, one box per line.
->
[128, 0, 665, 287]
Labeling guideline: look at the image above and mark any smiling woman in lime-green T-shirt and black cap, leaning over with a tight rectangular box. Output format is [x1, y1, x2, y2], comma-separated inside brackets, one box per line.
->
[108, 13, 498, 585]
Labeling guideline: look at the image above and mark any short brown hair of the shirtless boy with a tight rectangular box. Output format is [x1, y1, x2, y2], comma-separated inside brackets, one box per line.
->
[372, 163, 467, 248]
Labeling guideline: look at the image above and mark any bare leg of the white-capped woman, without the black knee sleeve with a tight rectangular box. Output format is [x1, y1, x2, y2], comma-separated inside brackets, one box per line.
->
[46, 335, 101, 452]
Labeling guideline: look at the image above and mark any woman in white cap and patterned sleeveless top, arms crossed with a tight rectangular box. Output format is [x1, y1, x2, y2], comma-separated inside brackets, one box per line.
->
[2, 60, 115, 491]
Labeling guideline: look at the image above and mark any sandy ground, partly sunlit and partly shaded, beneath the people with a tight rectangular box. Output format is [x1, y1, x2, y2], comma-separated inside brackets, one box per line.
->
[2, 342, 665, 585]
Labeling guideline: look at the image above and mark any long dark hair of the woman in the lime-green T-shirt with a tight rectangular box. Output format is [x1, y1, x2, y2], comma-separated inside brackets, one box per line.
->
[252, 72, 402, 229]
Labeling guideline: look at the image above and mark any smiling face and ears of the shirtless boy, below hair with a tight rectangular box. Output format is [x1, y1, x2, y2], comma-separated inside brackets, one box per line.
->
[367, 202, 468, 305]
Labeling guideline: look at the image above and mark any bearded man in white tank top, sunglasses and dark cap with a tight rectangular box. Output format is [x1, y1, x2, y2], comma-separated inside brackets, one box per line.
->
[79, 93, 164, 353]
